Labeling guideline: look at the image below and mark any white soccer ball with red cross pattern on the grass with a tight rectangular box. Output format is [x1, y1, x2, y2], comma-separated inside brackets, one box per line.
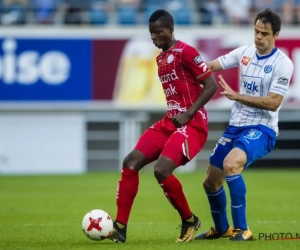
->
[82, 209, 113, 240]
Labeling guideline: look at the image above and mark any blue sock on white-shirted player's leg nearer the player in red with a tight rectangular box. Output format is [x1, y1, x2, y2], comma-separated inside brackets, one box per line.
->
[206, 186, 229, 234]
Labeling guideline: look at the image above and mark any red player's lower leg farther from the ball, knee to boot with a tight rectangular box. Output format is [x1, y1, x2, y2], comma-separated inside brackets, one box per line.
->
[154, 156, 201, 242]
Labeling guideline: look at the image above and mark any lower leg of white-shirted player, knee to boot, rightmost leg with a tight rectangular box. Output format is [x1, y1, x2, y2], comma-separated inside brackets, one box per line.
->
[223, 148, 253, 241]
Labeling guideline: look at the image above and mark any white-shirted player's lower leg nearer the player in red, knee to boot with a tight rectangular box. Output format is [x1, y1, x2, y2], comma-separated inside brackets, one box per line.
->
[195, 165, 233, 240]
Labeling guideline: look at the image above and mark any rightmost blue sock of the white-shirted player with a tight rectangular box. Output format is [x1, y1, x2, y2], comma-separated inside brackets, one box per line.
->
[226, 174, 248, 230]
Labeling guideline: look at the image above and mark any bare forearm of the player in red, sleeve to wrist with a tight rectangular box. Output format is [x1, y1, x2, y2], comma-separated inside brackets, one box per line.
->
[187, 75, 218, 116]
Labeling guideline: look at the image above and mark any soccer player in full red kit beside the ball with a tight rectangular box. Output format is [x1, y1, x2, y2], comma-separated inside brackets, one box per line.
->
[108, 10, 217, 242]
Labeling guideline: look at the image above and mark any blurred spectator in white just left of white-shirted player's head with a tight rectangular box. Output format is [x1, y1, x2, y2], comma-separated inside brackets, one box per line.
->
[221, 0, 251, 25]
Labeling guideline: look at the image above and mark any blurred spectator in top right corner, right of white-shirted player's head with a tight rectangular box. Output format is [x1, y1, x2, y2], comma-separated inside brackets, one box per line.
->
[282, 0, 300, 24]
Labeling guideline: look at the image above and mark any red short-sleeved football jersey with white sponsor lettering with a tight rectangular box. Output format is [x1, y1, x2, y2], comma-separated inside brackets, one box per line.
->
[156, 41, 212, 124]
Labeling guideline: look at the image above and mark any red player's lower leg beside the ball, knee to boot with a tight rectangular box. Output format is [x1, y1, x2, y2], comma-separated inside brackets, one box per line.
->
[107, 150, 148, 243]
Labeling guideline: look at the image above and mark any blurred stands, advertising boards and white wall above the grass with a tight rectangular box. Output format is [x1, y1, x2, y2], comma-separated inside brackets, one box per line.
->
[0, 0, 300, 174]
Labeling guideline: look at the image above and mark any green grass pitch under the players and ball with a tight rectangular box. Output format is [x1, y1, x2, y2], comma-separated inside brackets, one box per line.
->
[0, 168, 300, 250]
